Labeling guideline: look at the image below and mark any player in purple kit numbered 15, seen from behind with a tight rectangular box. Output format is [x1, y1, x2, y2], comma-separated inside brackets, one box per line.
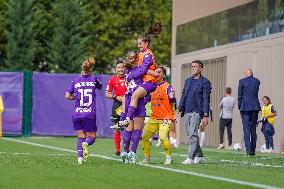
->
[65, 57, 102, 164]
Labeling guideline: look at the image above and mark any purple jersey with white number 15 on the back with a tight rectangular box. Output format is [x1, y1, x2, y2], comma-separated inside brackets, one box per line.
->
[67, 75, 102, 119]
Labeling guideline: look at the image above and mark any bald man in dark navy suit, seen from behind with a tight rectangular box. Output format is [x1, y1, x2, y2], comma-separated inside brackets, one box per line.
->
[238, 69, 260, 156]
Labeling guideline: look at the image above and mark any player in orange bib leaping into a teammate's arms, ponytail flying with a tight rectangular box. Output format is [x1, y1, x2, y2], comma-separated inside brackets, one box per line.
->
[120, 22, 164, 125]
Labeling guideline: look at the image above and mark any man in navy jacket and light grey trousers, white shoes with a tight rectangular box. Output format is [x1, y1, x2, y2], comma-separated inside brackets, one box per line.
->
[178, 60, 211, 164]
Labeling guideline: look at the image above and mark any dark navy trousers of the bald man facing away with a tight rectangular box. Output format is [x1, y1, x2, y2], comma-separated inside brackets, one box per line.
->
[241, 111, 258, 153]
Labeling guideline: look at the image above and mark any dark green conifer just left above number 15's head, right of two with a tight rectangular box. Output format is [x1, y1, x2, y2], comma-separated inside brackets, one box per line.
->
[49, 0, 88, 73]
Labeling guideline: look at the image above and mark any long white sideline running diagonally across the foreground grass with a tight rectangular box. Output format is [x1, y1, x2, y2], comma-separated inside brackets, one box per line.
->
[3, 137, 280, 189]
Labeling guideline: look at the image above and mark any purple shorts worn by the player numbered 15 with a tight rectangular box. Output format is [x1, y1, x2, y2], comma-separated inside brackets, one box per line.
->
[72, 118, 97, 132]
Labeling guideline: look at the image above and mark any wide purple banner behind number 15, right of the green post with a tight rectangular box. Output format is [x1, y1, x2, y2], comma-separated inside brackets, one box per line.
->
[32, 72, 112, 137]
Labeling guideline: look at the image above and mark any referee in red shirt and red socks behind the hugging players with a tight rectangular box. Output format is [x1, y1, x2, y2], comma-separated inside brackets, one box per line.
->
[106, 61, 126, 156]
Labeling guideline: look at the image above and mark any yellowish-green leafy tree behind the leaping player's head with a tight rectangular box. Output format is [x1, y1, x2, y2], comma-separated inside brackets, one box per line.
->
[84, 0, 172, 73]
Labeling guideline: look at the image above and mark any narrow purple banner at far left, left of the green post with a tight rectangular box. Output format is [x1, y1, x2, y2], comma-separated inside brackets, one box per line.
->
[0, 72, 24, 135]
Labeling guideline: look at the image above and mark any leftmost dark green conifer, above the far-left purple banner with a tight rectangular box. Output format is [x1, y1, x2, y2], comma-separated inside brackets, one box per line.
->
[5, 0, 36, 70]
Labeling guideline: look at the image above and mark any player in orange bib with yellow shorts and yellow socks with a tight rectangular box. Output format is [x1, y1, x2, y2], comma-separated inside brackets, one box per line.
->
[142, 67, 176, 164]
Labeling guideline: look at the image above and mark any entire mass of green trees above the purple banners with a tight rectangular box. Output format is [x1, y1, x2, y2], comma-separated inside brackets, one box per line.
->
[0, 0, 172, 73]
